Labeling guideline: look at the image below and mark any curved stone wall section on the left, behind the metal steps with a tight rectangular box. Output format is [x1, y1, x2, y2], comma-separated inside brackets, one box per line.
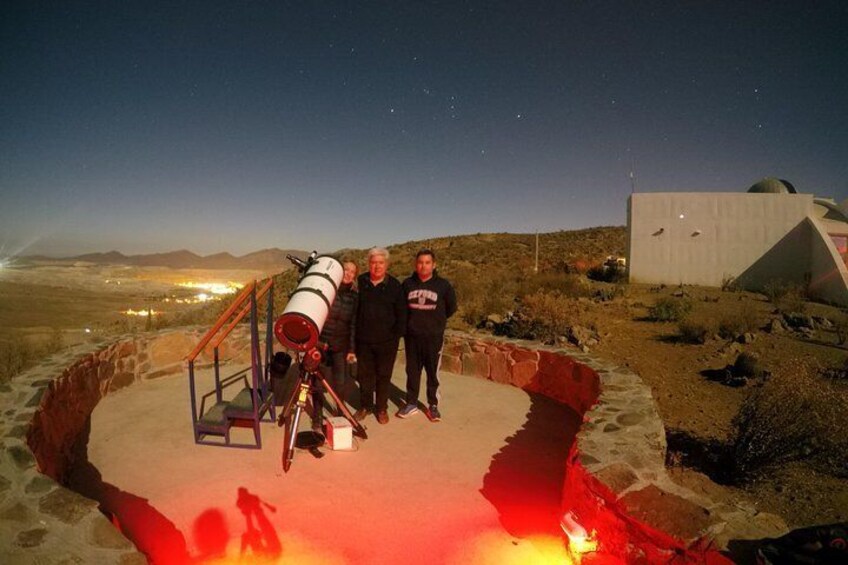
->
[0, 328, 250, 564]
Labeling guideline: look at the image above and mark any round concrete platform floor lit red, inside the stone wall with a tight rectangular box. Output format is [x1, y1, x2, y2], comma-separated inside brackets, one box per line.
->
[72, 367, 580, 564]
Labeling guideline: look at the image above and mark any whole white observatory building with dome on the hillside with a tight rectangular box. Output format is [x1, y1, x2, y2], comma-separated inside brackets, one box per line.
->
[627, 178, 848, 306]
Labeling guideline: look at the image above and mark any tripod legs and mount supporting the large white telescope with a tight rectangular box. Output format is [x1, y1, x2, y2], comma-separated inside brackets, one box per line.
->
[277, 348, 368, 473]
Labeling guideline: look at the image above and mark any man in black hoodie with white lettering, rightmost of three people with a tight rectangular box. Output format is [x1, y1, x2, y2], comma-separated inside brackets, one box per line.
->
[397, 249, 456, 422]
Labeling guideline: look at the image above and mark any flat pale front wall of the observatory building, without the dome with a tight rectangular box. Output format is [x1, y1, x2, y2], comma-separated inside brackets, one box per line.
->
[627, 193, 813, 288]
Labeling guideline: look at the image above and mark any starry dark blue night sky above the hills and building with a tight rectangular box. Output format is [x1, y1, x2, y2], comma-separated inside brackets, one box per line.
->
[0, 0, 848, 255]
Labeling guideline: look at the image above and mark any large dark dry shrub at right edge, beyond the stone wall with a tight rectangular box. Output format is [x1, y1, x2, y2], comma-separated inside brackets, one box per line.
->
[732, 370, 848, 480]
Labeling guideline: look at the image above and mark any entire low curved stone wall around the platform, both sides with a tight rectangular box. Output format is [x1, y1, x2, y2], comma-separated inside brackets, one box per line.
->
[0, 328, 785, 563]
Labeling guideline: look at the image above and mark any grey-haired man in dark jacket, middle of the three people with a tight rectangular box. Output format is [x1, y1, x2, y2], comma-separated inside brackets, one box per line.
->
[354, 247, 406, 424]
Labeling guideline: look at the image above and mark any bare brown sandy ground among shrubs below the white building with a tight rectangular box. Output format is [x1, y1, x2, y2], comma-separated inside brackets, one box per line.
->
[584, 285, 848, 527]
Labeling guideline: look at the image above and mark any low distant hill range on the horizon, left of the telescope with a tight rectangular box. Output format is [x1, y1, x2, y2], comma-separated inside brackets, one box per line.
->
[22, 247, 309, 271]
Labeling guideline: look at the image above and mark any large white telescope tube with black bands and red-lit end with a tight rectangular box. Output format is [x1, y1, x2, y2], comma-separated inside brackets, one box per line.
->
[274, 255, 344, 351]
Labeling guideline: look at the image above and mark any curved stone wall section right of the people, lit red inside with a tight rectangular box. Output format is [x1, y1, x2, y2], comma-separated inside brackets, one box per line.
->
[442, 332, 787, 563]
